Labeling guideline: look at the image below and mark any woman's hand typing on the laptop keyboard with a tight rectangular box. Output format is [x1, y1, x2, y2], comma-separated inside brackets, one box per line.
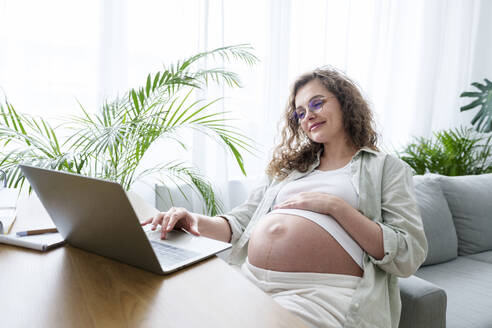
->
[142, 207, 200, 239]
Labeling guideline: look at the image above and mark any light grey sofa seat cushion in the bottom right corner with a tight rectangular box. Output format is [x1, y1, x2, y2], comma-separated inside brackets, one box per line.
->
[415, 256, 492, 328]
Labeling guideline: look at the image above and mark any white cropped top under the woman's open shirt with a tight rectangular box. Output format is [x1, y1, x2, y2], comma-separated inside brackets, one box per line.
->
[270, 163, 364, 268]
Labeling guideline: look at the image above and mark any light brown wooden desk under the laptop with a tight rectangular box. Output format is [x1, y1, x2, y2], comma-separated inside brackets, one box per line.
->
[0, 199, 304, 328]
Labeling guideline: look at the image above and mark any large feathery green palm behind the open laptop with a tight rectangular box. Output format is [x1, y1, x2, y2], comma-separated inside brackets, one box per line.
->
[0, 45, 258, 215]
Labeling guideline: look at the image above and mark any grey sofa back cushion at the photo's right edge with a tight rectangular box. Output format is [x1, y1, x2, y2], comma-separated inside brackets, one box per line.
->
[437, 174, 492, 255]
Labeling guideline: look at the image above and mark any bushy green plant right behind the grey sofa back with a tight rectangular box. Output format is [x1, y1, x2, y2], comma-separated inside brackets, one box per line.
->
[397, 127, 492, 176]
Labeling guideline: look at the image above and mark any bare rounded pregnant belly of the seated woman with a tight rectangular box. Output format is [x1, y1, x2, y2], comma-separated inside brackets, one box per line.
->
[248, 214, 363, 277]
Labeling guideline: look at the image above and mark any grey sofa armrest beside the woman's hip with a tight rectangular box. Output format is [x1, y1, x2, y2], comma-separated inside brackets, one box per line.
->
[398, 276, 447, 328]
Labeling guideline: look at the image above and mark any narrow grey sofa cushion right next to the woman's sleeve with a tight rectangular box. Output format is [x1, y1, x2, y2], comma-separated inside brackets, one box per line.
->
[413, 175, 458, 265]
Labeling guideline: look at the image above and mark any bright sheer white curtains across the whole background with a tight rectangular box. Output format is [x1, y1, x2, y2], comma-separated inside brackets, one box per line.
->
[0, 0, 492, 208]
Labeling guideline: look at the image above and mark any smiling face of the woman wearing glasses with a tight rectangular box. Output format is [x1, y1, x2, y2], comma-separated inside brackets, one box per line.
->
[295, 79, 346, 144]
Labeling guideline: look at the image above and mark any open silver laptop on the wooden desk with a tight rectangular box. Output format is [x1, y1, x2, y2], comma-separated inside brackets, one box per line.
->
[19, 165, 231, 274]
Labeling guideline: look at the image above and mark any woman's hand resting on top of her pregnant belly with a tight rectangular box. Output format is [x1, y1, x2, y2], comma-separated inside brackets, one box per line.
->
[274, 192, 350, 219]
